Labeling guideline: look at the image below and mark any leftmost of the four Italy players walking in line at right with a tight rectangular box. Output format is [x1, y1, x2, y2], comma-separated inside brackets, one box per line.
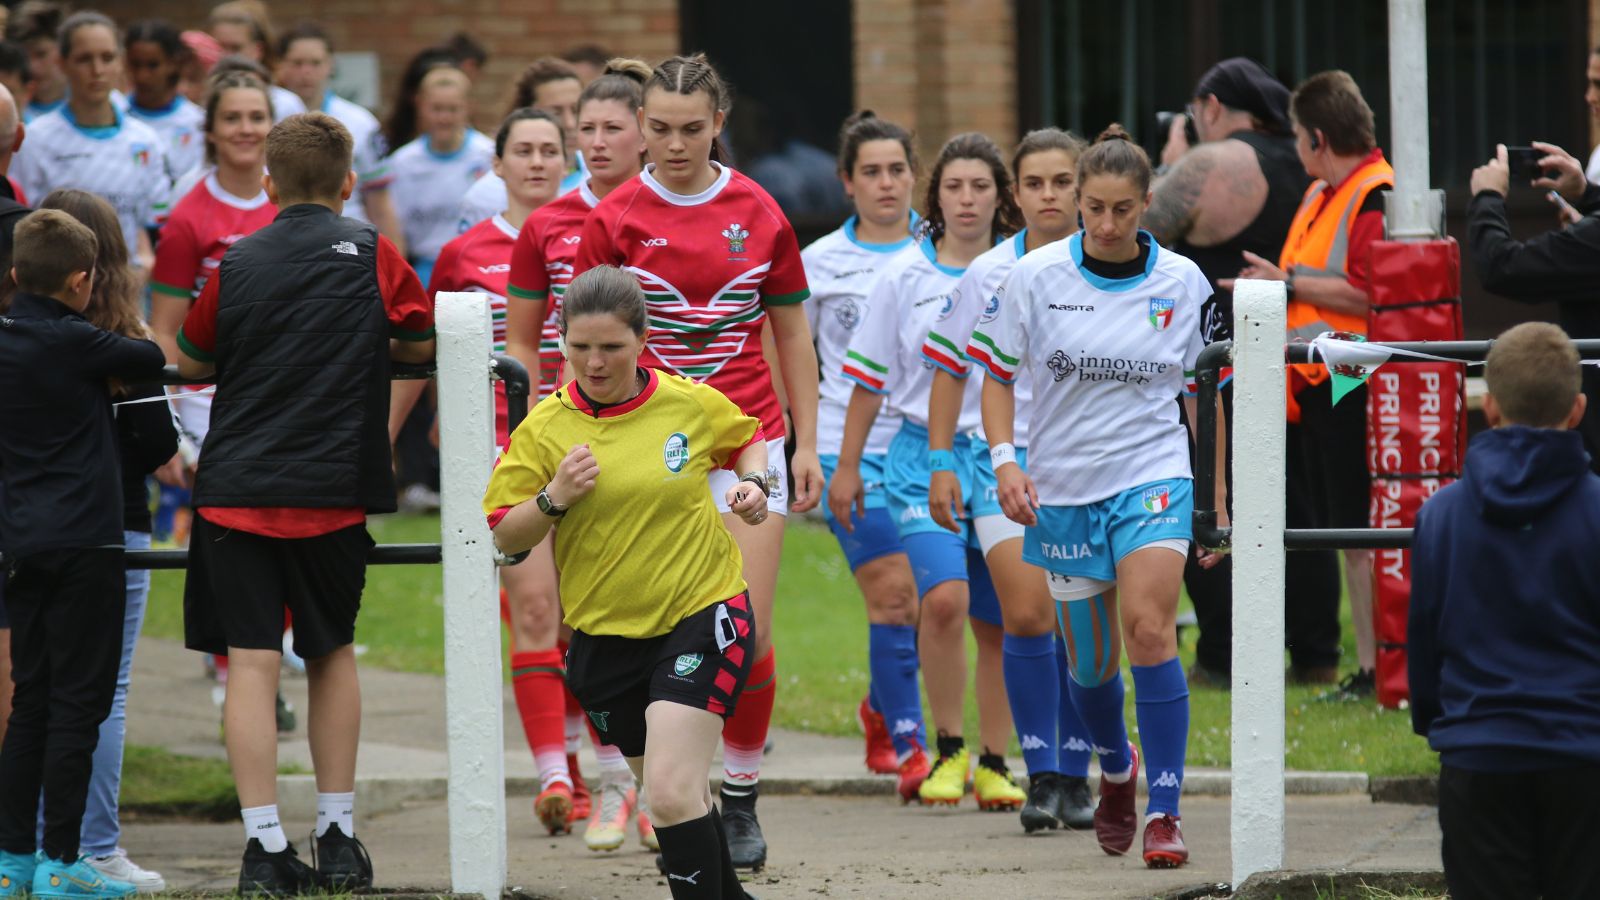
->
[800, 109, 920, 775]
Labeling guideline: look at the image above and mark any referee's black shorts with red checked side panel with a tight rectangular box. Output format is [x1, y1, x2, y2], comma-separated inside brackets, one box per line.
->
[566, 593, 755, 756]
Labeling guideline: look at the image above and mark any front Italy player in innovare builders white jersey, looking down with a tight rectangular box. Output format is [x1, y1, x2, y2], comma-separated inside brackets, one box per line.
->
[968, 125, 1227, 868]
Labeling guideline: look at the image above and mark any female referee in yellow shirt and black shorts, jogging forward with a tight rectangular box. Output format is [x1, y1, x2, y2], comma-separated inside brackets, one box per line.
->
[483, 266, 768, 900]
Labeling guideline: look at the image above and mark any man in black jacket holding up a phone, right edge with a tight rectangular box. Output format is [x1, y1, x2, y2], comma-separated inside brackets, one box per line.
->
[1467, 141, 1600, 472]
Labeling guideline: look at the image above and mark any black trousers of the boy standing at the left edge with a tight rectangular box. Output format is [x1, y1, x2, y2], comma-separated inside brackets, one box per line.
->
[0, 548, 126, 862]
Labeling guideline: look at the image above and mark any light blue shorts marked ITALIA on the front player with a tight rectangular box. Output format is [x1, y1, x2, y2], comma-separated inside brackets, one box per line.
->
[1022, 479, 1194, 581]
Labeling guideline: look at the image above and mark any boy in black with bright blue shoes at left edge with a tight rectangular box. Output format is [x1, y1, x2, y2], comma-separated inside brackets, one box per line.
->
[0, 210, 163, 897]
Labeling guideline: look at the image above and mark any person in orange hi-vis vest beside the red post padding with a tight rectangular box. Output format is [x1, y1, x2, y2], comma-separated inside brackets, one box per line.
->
[1219, 70, 1395, 698]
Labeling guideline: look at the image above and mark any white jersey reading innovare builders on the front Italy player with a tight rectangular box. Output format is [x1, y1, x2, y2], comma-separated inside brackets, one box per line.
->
[970, 232, 1211, 506]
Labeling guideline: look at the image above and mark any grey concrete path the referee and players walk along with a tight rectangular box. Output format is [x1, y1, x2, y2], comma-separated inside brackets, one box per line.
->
[123, 639, 1440, 900]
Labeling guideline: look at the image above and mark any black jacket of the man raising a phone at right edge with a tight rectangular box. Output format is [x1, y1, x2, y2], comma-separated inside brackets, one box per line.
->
[1467, 184, 1600, 472]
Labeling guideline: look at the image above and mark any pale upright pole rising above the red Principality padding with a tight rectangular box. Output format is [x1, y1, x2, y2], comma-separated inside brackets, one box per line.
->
[1387, 0, 1443, 240]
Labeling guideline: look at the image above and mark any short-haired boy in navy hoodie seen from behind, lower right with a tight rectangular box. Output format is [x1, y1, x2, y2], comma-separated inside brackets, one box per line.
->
[1410, 322, 1600, 900]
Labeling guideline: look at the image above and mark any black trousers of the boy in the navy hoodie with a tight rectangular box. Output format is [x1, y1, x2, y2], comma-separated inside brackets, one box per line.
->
[1438, 765, 1600, 900]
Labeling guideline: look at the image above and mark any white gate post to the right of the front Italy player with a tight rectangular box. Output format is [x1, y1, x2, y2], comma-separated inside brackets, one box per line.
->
[1232, 279, 1286, 889]
